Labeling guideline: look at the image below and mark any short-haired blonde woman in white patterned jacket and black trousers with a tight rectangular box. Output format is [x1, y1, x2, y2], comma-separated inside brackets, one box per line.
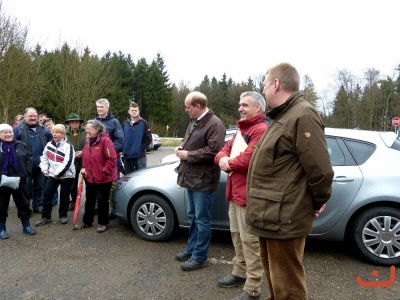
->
[35, 124, 75, 226]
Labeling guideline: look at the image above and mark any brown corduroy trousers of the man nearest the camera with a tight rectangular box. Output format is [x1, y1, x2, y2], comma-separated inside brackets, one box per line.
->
[259, 237, 307, 300]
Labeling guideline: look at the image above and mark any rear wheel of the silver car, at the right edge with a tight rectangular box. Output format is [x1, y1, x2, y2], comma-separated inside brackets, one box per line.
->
[350, 207, 400, 265]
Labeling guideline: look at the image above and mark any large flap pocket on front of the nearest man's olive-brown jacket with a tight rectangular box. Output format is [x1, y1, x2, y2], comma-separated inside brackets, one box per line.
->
[246, 188, 283, 231]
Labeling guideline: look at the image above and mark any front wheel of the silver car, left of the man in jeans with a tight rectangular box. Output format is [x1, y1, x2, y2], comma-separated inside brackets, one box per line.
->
[131, 195, 175, 242]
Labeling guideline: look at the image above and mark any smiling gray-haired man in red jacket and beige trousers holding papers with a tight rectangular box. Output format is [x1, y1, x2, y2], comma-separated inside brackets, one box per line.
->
[214, 92, 268, 299]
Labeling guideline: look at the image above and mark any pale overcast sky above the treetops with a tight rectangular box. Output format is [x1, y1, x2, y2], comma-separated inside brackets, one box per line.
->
[0, 0, 400, 92]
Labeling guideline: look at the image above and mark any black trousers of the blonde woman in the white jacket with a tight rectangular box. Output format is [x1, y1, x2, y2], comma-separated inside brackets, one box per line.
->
[42, 176, 74, 219]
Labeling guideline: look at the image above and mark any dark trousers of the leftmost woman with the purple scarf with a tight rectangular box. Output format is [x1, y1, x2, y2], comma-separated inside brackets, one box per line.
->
[0, 179, 32, 221]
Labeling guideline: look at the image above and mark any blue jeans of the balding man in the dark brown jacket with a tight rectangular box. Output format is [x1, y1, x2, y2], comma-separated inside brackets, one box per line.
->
[185, 189, 213, 262]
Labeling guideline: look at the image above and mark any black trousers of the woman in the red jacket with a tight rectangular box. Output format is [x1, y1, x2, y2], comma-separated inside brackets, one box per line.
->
[83, 180, 112, 225]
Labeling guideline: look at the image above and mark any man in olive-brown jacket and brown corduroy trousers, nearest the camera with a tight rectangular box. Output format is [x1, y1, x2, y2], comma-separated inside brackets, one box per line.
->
[246, 63, 333, 300]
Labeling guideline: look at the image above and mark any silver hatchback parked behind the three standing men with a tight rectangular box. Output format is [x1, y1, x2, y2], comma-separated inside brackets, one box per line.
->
[113, 128, 400, 265]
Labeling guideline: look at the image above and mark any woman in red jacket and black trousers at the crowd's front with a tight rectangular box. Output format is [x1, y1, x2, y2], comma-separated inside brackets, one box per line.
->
[74, 120, 117, 232]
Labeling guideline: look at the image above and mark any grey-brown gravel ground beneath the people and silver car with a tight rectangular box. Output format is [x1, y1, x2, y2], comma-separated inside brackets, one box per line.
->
[0, 147, 400, 300]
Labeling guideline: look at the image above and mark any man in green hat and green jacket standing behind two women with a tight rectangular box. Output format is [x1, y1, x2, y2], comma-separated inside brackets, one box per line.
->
[65, 113, 86, 211]
